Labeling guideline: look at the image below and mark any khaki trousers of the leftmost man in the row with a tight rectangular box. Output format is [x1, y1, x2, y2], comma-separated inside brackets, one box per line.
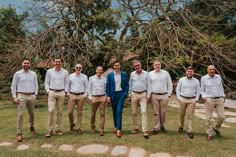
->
[17, 93, 36, 134]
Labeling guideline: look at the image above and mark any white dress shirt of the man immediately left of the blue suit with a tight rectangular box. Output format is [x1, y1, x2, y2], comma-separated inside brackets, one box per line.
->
[88, 75, 107, 98]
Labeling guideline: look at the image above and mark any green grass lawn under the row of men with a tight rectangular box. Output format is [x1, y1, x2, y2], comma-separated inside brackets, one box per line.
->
[0, 99, 236, 157]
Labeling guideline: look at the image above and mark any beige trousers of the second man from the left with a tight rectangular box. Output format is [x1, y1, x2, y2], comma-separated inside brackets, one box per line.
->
[48, 90, 65, 131]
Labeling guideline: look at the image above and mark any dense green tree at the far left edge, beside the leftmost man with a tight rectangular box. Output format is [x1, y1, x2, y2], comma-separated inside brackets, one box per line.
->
[0, 6, 27, 98]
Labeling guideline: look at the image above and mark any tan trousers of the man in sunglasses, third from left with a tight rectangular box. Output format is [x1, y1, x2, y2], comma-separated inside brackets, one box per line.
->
[68, 94, 85, 129]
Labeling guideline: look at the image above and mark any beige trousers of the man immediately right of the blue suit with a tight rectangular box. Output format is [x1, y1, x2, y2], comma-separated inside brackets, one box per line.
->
[131, 92, 148, 131]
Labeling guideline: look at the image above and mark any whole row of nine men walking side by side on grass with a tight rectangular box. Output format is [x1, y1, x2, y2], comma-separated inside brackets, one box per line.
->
[11, 58, 225, 142]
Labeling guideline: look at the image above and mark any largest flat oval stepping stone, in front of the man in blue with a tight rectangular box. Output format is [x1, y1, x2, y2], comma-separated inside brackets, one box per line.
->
[76, 144, 109, 154]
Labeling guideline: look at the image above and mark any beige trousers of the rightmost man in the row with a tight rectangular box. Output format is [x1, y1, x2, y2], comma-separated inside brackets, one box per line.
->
[205, 98, 224, 136]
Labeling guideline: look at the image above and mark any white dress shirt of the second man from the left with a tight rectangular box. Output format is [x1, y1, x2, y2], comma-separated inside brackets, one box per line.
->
[44, 68, 69, 92]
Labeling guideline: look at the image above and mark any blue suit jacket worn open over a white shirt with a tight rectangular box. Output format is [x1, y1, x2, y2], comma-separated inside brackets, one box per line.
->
[106, 71, 129, 100]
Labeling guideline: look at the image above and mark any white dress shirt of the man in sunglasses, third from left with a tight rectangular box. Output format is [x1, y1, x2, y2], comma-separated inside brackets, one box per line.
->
[67, 73, 88, 96]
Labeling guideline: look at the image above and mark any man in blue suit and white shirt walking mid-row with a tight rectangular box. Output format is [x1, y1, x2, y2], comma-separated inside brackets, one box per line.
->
[106, 61, 129, 138]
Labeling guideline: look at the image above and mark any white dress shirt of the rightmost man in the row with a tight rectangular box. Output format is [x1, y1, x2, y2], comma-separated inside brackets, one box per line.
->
[201, 74, 225, 98]
